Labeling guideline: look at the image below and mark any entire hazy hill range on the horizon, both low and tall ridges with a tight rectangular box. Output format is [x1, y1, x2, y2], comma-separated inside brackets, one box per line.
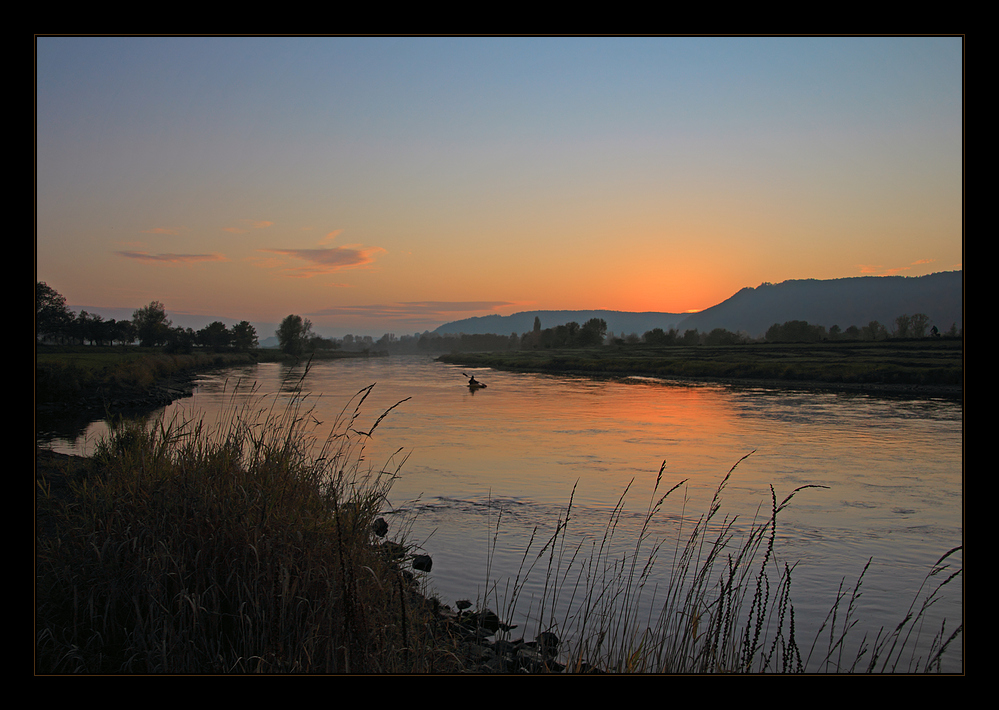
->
[434, 271, 964, 338]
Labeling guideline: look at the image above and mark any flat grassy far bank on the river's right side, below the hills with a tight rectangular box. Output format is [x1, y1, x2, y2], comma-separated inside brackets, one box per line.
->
[438, 337, 964, 395]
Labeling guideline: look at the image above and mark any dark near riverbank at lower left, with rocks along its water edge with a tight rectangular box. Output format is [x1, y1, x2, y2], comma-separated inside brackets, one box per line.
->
[35, 444, 564, 675]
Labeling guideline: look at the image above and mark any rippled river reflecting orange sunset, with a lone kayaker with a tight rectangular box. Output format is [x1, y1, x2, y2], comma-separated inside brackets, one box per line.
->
[37, 356, 963, 672]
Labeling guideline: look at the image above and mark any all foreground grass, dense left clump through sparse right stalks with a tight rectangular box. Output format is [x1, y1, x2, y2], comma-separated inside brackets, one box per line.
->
[35, 387, 963, 674]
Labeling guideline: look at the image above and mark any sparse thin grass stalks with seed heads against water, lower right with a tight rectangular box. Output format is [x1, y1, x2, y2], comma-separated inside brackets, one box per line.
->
[474, 457, 963, 673]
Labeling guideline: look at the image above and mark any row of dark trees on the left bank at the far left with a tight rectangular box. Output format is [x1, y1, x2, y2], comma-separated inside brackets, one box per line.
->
[35, 281, 258, 352]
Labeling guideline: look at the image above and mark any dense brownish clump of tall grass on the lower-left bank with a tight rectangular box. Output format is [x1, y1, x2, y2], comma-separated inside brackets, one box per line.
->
[36, 378, 458, 673]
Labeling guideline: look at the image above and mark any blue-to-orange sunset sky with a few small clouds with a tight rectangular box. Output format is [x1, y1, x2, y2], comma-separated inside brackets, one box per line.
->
[35, 36, 964, 339]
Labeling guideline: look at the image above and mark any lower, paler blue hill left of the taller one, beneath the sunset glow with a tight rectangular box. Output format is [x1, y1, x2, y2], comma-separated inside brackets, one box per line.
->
[434, 311, 687, 335]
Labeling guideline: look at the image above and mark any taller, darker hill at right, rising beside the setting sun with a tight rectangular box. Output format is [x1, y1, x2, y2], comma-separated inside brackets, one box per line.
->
[678, 271, 963, 338]
